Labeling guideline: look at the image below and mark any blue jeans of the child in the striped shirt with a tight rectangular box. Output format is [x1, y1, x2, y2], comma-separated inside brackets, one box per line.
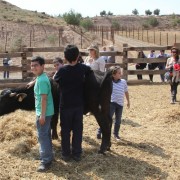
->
[98, 102, 123, 136]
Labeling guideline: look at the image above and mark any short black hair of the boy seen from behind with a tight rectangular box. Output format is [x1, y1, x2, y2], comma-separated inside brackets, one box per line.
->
[64, 45, 79, 63]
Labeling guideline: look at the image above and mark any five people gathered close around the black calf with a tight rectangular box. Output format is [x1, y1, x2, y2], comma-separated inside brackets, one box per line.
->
[30, 45, 130, 172]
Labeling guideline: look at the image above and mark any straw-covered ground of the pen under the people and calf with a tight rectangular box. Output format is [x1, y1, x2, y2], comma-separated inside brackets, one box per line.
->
[0, 83, 180, 180]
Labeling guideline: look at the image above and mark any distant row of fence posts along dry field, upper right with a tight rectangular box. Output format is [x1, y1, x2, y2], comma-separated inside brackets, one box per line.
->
[89, 26, 180, 46]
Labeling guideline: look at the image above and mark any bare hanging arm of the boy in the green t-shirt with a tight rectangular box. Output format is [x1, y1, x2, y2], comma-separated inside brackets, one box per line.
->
[39, 94, 47, 125]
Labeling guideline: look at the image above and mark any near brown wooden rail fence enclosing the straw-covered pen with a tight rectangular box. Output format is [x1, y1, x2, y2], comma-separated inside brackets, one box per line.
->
[0, 44, 172, 89]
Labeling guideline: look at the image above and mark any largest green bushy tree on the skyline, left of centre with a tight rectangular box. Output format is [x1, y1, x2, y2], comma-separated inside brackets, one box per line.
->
[63, 10, 82, 26]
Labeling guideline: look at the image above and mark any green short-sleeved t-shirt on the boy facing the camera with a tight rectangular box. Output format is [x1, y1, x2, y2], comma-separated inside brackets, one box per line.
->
[34, 73, 54, 116]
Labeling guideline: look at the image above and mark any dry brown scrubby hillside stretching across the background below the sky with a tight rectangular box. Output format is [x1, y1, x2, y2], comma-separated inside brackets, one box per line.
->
[0, 0, 180, 52]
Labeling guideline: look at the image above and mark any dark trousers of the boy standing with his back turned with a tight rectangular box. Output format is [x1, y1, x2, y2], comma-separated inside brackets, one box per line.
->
[60, 107, 83, 156]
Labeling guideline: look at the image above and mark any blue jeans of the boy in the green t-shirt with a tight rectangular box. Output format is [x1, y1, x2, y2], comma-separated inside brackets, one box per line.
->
[36, 116, 53, 164]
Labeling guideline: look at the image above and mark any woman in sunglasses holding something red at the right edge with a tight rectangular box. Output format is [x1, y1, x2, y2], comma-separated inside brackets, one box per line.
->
[166, 47, 180, 104]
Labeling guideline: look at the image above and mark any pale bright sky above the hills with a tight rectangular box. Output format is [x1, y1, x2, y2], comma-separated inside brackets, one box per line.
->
[6, 0, 180, 17]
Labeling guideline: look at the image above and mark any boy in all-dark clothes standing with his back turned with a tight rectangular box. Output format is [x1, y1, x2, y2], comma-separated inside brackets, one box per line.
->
[54, 45, 91, 161]
